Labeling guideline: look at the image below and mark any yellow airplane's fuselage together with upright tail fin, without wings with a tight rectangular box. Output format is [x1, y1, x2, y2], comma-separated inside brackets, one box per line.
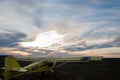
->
[0, 56, 56, 80]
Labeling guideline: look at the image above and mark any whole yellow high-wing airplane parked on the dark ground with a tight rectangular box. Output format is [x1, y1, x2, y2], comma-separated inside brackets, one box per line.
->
[0, 55, 102, 80]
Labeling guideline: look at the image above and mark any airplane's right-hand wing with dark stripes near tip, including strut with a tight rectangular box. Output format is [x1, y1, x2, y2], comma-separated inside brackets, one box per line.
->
[46, 56, 103, 68]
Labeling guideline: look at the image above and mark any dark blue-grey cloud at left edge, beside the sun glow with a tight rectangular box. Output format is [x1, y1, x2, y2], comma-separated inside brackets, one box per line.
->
[0, 32, 26, 47]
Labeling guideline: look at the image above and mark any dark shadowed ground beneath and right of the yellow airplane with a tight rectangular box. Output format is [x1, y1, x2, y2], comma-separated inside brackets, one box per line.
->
[2, 58, 120, 80]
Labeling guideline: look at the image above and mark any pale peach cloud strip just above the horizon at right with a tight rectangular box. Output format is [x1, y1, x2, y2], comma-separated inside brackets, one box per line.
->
[80, 47, 120, 58]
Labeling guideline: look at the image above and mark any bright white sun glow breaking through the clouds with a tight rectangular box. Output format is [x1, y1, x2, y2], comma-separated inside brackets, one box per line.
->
[21, 31, 64, 48]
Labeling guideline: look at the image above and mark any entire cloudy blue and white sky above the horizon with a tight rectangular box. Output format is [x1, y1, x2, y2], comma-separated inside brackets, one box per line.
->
[0, 0, 120, 57]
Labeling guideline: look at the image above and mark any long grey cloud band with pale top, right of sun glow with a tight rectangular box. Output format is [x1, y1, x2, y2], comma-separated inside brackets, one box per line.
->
[64, 36, 120, 52]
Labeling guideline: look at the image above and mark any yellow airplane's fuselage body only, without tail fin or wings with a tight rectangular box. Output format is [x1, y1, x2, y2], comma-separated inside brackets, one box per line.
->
[4, 61, 54, 79]
